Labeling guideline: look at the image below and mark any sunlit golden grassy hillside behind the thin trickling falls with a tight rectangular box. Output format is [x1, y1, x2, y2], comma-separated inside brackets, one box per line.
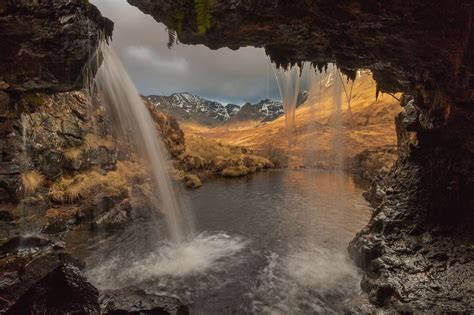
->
[182, 73, 401, 167]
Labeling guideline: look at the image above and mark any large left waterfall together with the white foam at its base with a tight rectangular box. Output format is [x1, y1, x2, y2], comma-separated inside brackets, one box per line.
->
[81, 42, 246, 294]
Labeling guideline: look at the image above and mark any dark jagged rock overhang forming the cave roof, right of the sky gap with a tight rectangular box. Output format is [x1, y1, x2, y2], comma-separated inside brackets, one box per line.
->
[128, 0, 474, 102]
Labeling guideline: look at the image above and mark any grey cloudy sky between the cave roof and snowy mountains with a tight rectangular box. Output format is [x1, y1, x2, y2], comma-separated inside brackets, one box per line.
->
[91, 0, 280, 105]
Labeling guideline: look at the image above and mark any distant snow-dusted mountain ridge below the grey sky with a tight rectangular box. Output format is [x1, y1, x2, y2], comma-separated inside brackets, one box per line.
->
[146, 93, 302, 125]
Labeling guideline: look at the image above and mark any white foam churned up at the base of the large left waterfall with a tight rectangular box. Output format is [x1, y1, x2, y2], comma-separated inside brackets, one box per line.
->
[86, 233, 247, 289]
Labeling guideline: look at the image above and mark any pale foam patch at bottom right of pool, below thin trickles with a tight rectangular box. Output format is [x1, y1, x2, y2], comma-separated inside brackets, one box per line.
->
[249, 248, 359, 314]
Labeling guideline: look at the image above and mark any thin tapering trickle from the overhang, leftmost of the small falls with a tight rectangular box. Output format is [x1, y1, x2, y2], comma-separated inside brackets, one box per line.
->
[273, 61, 301, 166]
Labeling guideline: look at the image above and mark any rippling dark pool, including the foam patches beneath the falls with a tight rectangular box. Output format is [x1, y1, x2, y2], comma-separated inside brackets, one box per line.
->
[68, 170, 370, 314]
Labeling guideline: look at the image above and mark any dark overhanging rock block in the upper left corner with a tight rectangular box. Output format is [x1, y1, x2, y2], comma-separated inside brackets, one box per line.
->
[0, 0, 113, 91]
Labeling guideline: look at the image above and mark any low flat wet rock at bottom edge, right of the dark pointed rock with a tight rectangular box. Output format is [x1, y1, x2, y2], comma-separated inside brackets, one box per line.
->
[99, 287, 189, 315]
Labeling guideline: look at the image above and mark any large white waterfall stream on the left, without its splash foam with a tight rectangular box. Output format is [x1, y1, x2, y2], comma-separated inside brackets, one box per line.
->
[91, 41, 194, 242]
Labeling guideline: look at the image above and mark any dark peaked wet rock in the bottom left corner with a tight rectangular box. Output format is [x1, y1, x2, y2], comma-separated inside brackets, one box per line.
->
[6, 264, 100, 315]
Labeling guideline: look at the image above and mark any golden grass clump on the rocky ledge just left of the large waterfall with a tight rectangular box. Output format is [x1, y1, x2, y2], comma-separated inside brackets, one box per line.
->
[49, 171, 128, 203]
